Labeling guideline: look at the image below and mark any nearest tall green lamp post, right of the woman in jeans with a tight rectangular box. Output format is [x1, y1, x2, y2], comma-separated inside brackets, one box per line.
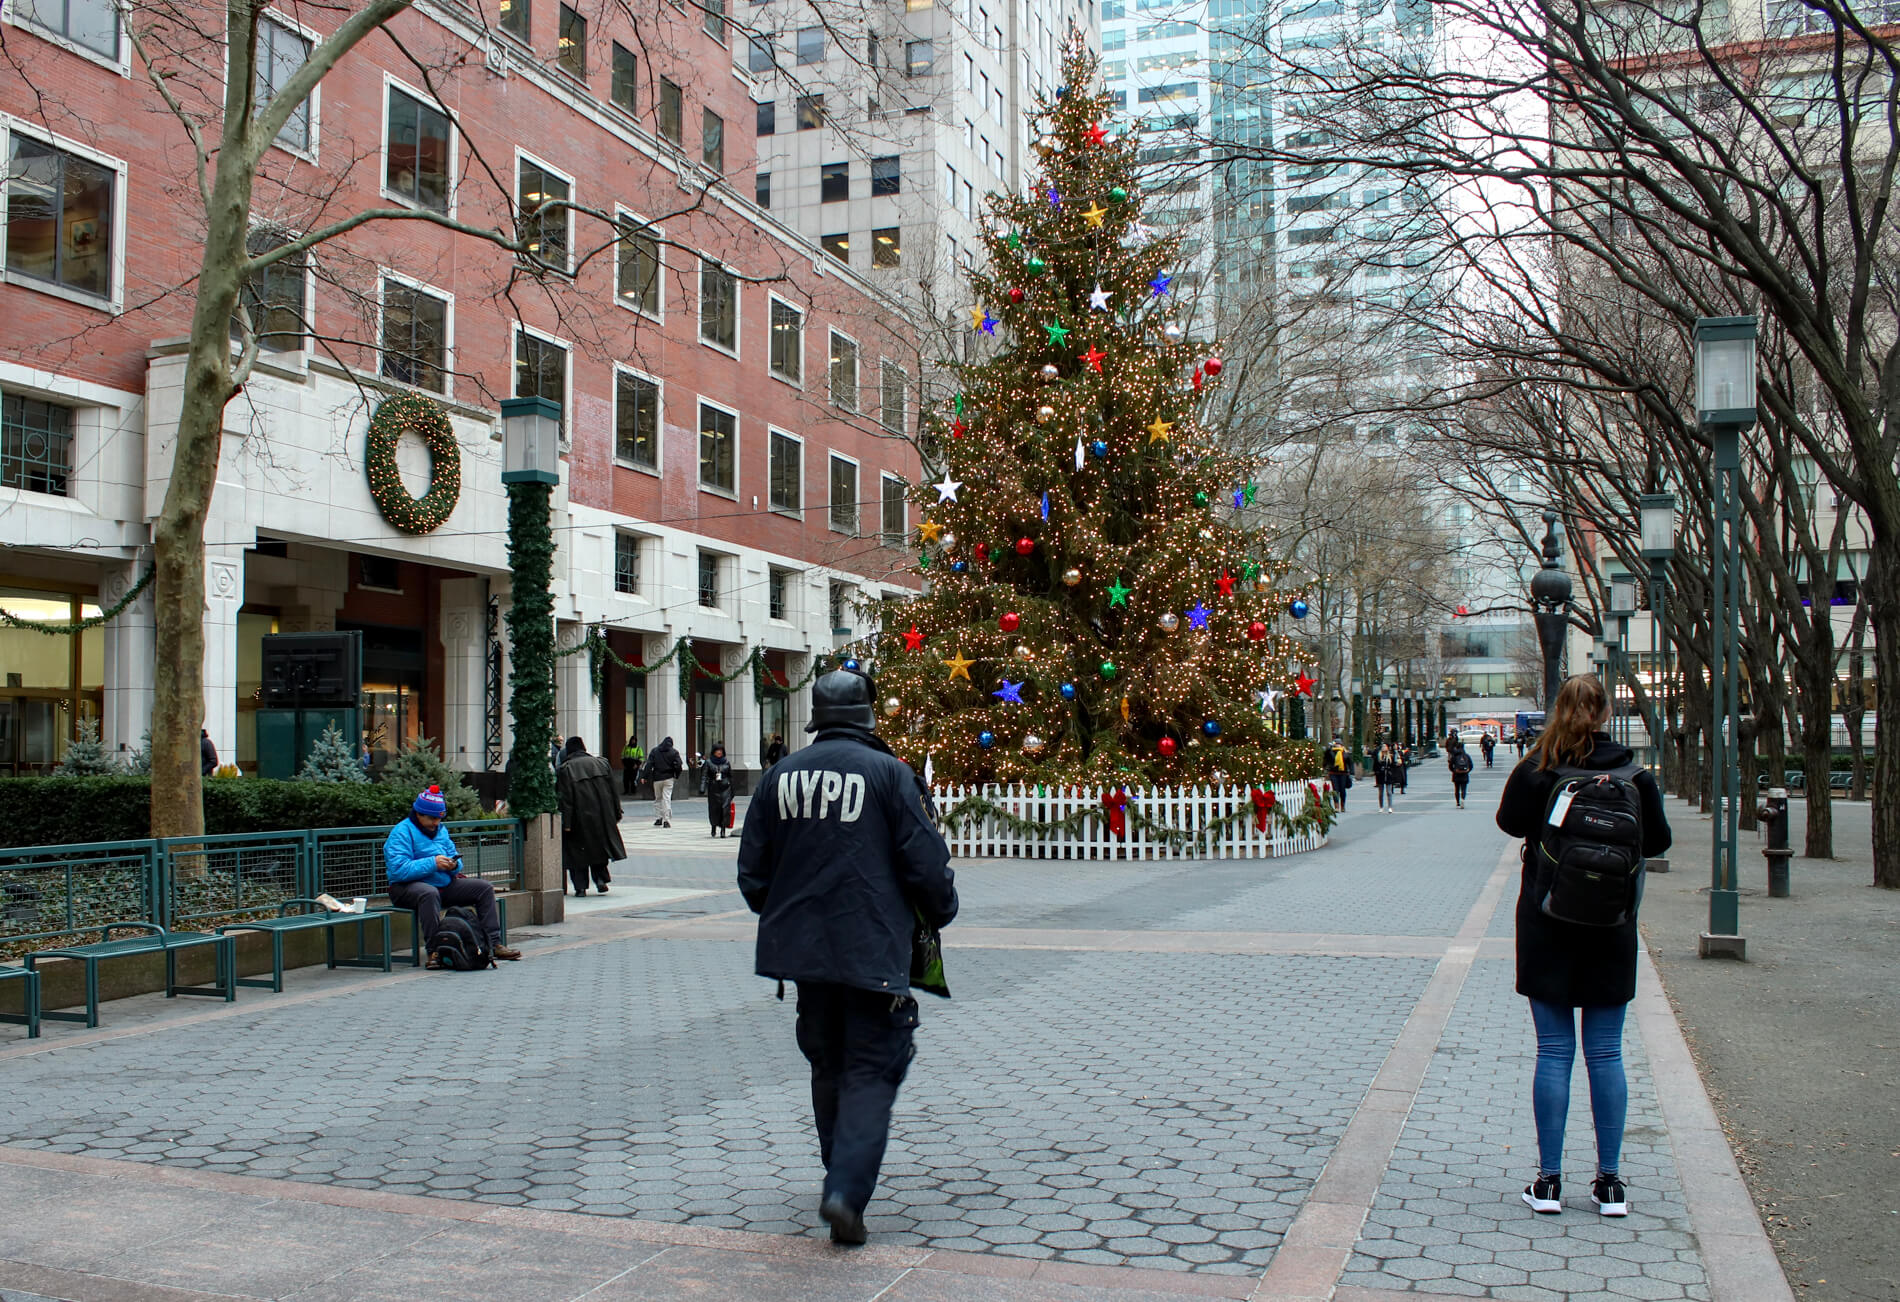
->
[1695, 316, 1756, 958]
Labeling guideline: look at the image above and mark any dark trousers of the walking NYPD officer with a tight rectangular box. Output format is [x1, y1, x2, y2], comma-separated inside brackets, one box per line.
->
[798, 981, 918, 1211]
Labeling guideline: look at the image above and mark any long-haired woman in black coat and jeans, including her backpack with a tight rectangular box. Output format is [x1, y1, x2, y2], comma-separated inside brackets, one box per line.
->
[1497, 675, 1670, 1216]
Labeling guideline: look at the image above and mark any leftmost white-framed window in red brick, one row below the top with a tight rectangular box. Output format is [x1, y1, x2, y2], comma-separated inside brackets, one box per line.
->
[6, 135, 118, 298]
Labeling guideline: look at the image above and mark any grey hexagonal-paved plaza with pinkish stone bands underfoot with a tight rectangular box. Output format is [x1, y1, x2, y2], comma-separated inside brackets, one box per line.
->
[0, 768, 1788, 1302]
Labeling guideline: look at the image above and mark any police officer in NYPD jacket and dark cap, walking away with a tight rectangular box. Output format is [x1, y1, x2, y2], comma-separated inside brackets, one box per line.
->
[739, 669, 958, 1243]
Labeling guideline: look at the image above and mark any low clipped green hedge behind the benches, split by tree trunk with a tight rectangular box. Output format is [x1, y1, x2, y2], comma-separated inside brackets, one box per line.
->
[0, 777, 414, 846]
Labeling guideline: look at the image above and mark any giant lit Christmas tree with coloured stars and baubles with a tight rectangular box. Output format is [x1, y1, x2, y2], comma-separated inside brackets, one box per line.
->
[876, 40, 1315, 787]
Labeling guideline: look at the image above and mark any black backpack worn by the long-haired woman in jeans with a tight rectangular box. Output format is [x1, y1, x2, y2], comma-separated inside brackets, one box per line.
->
[1535, 764, 1644, 928]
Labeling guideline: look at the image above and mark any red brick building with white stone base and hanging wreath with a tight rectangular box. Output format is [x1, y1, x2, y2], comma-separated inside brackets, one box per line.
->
[0, 0, 918, 774]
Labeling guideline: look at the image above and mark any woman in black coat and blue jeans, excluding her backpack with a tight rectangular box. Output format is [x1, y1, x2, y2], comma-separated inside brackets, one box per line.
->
[1497, 675, 1670, 1216]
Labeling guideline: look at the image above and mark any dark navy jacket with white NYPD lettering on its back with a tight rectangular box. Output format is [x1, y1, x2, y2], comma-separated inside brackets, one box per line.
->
[739, 728, 958, 992]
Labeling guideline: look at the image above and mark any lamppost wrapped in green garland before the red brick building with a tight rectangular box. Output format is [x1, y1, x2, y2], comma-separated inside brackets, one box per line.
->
[502, 397, 561, 817]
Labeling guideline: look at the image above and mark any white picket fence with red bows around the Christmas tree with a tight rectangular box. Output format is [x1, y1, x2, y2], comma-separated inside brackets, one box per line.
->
[935, 779, 1326, 859]
